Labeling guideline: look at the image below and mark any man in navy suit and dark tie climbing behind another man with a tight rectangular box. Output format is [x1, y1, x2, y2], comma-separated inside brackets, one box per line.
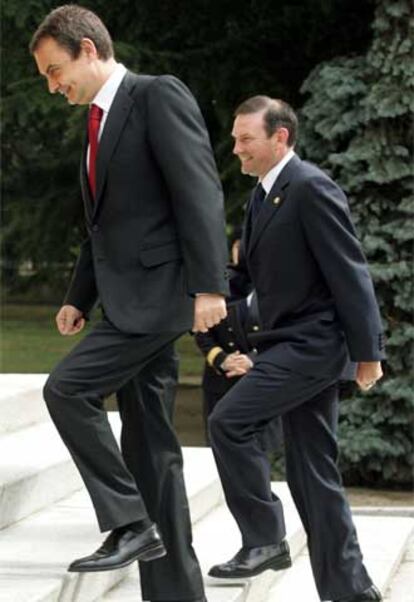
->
[210, 96, 384, 602]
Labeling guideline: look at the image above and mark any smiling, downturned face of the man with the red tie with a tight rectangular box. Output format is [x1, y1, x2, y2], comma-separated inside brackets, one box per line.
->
[34, 37, 98, 105]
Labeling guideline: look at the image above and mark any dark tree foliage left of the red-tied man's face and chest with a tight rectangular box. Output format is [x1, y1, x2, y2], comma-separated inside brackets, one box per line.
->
[1, 0, 83, 291]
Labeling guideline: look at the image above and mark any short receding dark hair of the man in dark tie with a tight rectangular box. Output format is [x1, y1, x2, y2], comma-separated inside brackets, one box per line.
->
[234, 96, 298, 146]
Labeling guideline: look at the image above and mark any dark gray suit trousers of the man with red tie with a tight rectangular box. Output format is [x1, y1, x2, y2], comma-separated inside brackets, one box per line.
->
[44, 321, 203, 602]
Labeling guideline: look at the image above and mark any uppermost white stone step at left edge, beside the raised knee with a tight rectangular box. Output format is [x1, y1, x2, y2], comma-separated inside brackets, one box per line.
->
[0, 374, 49, 434]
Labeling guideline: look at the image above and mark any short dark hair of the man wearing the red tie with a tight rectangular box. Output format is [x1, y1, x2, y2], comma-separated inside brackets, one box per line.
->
[29, 4, 114, 61]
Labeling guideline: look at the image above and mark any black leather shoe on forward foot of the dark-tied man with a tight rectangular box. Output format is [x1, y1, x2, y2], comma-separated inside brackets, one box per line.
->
[208, 541, 292, 579]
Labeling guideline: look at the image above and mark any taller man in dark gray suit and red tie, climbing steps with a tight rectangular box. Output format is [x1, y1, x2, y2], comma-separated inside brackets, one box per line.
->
[30, 5, 227, 602]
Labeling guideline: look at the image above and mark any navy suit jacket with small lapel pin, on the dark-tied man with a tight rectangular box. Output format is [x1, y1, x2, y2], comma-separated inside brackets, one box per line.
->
[232, 156, 385, 377]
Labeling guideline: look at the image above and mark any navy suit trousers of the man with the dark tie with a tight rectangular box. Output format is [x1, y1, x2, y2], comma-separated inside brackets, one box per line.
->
[210, 350, 371, 600]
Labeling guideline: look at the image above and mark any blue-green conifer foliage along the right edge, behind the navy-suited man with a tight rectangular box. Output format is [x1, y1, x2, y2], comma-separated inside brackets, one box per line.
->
[302, 0, 414, 485]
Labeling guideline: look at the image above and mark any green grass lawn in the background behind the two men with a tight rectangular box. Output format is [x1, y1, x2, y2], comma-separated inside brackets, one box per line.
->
[0, 304, 203, 379]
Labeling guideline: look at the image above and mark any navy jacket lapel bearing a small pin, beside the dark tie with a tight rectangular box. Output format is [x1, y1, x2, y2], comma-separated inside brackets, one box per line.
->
[248, 155, 300, 255]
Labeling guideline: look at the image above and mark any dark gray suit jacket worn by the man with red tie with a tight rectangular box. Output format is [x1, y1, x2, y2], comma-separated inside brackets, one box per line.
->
[65, 72, 227, 333]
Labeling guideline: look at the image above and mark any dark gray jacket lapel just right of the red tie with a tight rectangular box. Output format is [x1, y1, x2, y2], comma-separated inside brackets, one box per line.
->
[92, 74, 133, 213]
